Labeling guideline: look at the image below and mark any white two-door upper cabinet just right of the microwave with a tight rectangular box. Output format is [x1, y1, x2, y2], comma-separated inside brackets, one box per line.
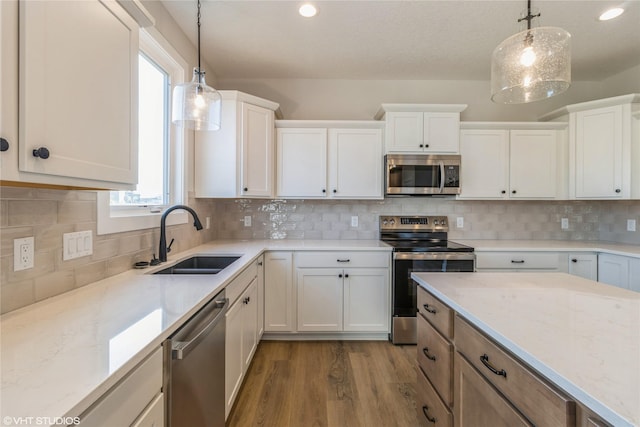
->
[459, 122, 566, 199]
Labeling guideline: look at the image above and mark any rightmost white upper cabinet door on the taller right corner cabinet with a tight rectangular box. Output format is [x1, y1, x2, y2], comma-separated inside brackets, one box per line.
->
[575, 106, 629, 199]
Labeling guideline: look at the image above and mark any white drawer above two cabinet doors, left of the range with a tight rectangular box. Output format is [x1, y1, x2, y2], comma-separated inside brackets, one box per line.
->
[295, 251, 391, 268]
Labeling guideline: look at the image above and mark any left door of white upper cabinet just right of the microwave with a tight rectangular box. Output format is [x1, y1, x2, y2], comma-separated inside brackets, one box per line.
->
[459, 129, 509, 199]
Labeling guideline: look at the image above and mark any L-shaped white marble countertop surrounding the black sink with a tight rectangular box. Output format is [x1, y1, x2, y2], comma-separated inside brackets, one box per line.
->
[0, 240, 391, 425]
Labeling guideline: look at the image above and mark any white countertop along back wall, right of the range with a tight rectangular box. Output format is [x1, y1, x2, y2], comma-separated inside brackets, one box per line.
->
[451, 239, 640, 258]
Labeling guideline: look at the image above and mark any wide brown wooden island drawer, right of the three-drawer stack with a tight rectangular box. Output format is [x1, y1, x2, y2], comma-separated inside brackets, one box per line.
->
[455, 316, 576, 427]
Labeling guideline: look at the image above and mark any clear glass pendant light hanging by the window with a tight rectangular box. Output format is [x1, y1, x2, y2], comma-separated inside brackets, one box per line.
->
[171, 0, 222, 130]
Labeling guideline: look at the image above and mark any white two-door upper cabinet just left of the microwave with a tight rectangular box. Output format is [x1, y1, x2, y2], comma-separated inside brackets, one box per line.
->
[276, 120, 383, 199]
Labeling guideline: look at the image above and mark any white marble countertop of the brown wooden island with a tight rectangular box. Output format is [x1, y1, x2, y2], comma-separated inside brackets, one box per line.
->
[412, 273, 640, 427]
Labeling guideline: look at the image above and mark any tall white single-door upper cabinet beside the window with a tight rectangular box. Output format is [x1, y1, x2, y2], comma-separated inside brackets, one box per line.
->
[194, 90, 279, 198]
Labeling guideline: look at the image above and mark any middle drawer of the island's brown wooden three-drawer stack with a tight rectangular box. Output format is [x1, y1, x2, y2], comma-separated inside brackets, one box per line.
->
[417, 316, 453, 407]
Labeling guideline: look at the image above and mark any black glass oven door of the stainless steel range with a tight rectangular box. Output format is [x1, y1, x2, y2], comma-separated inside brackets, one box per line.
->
[393, 252, 476, 316]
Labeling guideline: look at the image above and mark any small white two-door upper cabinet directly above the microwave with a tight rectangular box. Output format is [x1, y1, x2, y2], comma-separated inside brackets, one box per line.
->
[375, 104, 467, 153]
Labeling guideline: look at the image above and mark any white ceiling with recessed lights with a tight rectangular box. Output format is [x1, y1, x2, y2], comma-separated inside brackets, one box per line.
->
[162, 0, 640, 81]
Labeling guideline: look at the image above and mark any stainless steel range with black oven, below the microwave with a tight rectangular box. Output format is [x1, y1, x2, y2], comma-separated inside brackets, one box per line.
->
[380, 216, 476, 344]
